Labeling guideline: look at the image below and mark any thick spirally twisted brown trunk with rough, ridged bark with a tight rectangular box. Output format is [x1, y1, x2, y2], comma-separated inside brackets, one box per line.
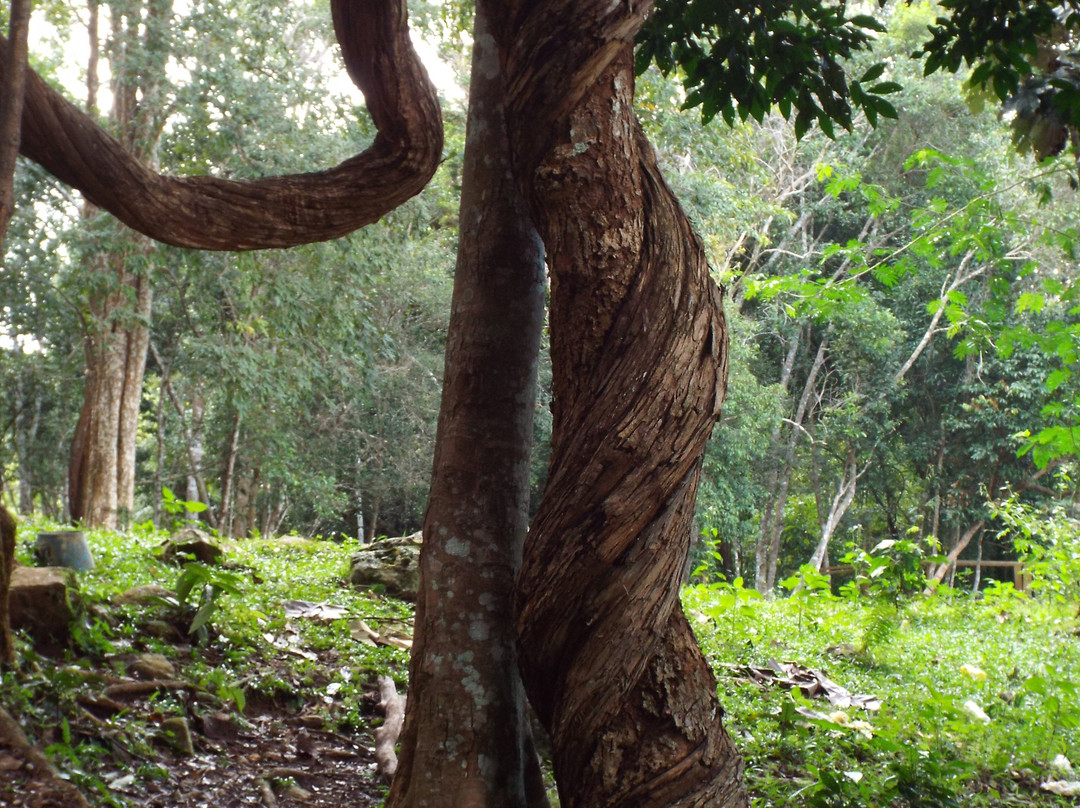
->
[501, 1, 746, 808]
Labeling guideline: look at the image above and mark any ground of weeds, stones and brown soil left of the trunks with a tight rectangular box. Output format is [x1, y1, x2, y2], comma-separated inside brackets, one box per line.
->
[0, 530, 411, 808]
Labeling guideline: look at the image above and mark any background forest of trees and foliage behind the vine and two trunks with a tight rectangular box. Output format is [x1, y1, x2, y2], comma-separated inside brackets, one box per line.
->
[10, 1, 1078, 592]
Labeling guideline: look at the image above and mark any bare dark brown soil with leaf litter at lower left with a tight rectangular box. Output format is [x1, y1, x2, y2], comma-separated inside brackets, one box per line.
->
[0, 650, 386, 808]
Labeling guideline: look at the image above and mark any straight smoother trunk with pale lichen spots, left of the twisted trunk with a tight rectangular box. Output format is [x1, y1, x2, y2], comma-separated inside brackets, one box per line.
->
[387, 4, 545, 808]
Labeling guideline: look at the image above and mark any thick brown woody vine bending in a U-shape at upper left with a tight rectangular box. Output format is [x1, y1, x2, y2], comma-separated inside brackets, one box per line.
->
[0, 0, 442, 250]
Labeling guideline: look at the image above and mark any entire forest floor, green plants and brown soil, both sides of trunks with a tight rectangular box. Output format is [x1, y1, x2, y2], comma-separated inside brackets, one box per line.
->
[0, 525, 1080, 808]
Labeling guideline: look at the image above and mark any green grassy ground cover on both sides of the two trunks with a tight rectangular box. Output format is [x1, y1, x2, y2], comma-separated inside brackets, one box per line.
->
[0, 514, 1080, 808]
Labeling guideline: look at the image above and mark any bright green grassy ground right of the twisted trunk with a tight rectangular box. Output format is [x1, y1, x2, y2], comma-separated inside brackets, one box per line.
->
[684, 583, 1080, 807]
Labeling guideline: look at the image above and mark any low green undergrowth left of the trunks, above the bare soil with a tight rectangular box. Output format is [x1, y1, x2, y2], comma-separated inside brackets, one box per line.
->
[0, 522, 411, 806]
